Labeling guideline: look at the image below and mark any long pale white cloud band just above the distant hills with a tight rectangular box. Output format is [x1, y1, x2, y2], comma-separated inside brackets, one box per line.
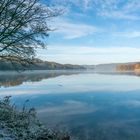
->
[39, 45, 140, 65]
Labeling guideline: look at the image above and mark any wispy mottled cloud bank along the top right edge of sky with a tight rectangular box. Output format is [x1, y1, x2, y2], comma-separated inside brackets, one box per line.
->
[50, 0, 140, 20]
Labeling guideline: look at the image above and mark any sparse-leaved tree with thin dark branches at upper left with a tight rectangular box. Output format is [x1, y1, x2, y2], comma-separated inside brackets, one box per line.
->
[0, 0, 59, 65]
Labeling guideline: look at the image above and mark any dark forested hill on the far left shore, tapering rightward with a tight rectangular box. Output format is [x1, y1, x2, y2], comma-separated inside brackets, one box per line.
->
[0, 59, 86, 71]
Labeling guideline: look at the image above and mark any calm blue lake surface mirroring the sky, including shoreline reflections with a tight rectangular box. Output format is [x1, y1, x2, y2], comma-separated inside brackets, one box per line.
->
[0, 71, 140, 140]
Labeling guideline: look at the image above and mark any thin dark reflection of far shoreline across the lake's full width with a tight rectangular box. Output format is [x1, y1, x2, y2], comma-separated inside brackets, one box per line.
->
[0, 70, 140, 87]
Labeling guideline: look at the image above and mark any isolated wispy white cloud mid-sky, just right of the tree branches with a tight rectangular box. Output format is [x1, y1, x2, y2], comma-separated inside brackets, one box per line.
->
[54, 20, 101, 39]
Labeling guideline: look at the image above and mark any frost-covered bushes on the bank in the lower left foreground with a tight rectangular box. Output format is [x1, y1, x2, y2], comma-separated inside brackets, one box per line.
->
[0, 96, 70, 140]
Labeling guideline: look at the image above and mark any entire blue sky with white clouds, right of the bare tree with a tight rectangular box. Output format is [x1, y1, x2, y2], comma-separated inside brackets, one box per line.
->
[39, 0, 140, 64]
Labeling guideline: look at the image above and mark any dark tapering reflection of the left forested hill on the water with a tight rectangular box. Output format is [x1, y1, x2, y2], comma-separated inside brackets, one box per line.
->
[0, 71, 81, 87]
